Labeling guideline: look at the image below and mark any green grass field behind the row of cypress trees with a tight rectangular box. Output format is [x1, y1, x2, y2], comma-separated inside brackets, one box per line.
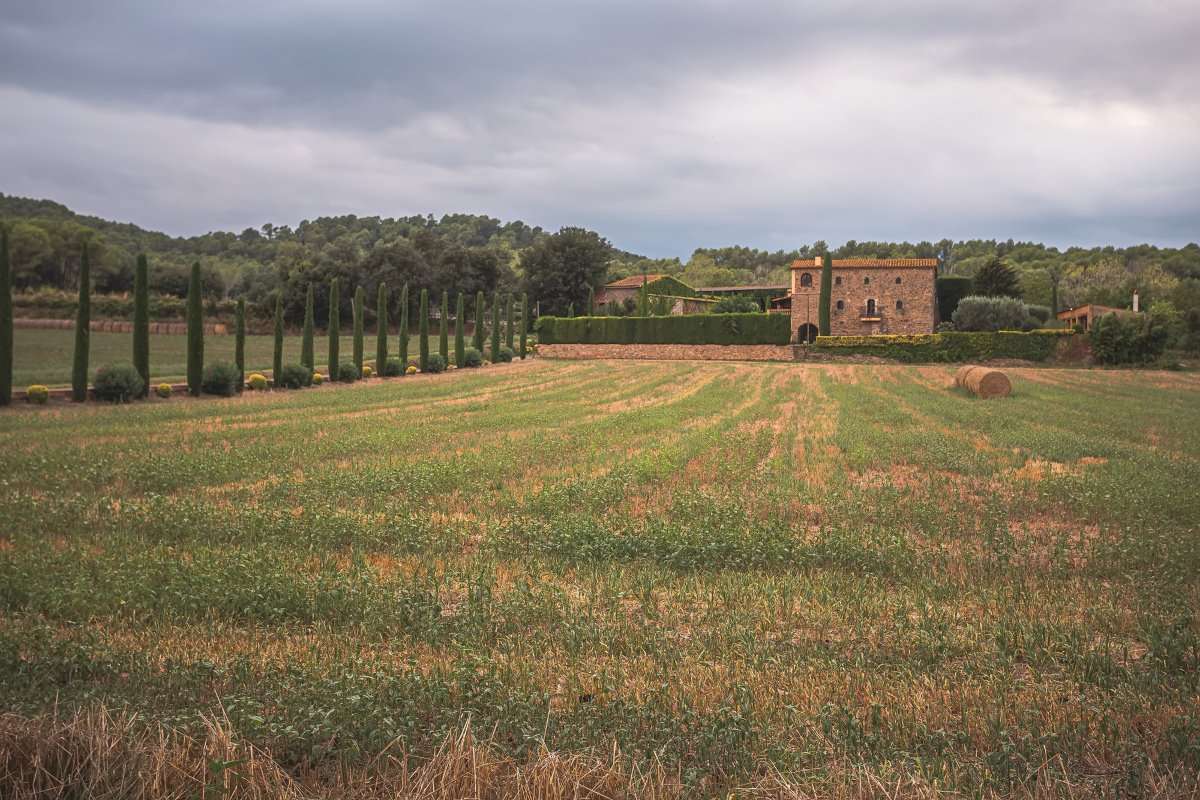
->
[12, 327, 369, 389]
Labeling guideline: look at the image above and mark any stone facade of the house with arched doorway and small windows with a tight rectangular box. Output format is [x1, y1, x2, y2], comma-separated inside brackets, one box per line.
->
[788, 258, 937, 341]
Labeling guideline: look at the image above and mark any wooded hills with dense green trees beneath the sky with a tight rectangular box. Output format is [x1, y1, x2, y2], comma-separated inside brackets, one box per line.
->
[0, 194, 1200, 324]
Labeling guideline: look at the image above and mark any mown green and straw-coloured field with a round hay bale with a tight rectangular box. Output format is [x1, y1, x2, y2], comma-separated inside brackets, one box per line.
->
[0, 360, 1200, 798]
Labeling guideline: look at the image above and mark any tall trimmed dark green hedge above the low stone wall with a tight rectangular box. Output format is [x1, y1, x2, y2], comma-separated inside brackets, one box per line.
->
[536, 314, 792, 344]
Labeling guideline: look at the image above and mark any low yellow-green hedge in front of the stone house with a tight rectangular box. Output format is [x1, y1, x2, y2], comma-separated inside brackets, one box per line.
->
[814, 330, 1070, 363]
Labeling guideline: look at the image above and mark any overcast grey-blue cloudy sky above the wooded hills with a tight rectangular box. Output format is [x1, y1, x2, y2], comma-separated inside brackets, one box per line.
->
[0, 0, 1200, 255]
